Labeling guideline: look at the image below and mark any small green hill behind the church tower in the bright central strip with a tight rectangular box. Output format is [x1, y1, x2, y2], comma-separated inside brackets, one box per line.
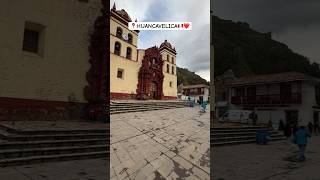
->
[177, 67, 210, 85]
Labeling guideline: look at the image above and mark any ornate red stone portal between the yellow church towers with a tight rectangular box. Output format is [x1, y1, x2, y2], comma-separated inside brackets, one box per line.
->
[137, 46, 164, 100]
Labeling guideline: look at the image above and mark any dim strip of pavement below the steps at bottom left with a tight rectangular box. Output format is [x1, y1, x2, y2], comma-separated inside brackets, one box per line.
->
[0, 159, 109, 180]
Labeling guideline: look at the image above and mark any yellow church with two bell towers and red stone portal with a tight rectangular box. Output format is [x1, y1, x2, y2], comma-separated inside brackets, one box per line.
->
[110, 4, 177, 100]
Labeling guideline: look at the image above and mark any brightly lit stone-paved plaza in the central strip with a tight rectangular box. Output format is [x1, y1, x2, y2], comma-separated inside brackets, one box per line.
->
[110, 107, 210, 180]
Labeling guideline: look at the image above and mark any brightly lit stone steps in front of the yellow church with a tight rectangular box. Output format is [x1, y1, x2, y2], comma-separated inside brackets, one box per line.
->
[110, 101, 188, 114]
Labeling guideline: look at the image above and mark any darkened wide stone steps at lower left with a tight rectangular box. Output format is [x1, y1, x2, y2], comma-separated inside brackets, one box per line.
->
[0, 125, 110, 167]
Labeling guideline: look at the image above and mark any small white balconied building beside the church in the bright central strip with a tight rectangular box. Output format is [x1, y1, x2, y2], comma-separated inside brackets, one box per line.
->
[181, 84, 210, 102]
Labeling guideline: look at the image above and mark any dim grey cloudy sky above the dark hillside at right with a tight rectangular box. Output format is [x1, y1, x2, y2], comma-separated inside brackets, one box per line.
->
[211, 0, 320, 63]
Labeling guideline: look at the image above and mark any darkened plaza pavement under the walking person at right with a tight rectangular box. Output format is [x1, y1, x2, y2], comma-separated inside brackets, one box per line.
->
[212, 136, 320, 180]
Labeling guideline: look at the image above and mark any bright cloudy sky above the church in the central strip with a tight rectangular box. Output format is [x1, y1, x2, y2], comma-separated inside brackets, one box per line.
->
[110, 0, 210, 81]
